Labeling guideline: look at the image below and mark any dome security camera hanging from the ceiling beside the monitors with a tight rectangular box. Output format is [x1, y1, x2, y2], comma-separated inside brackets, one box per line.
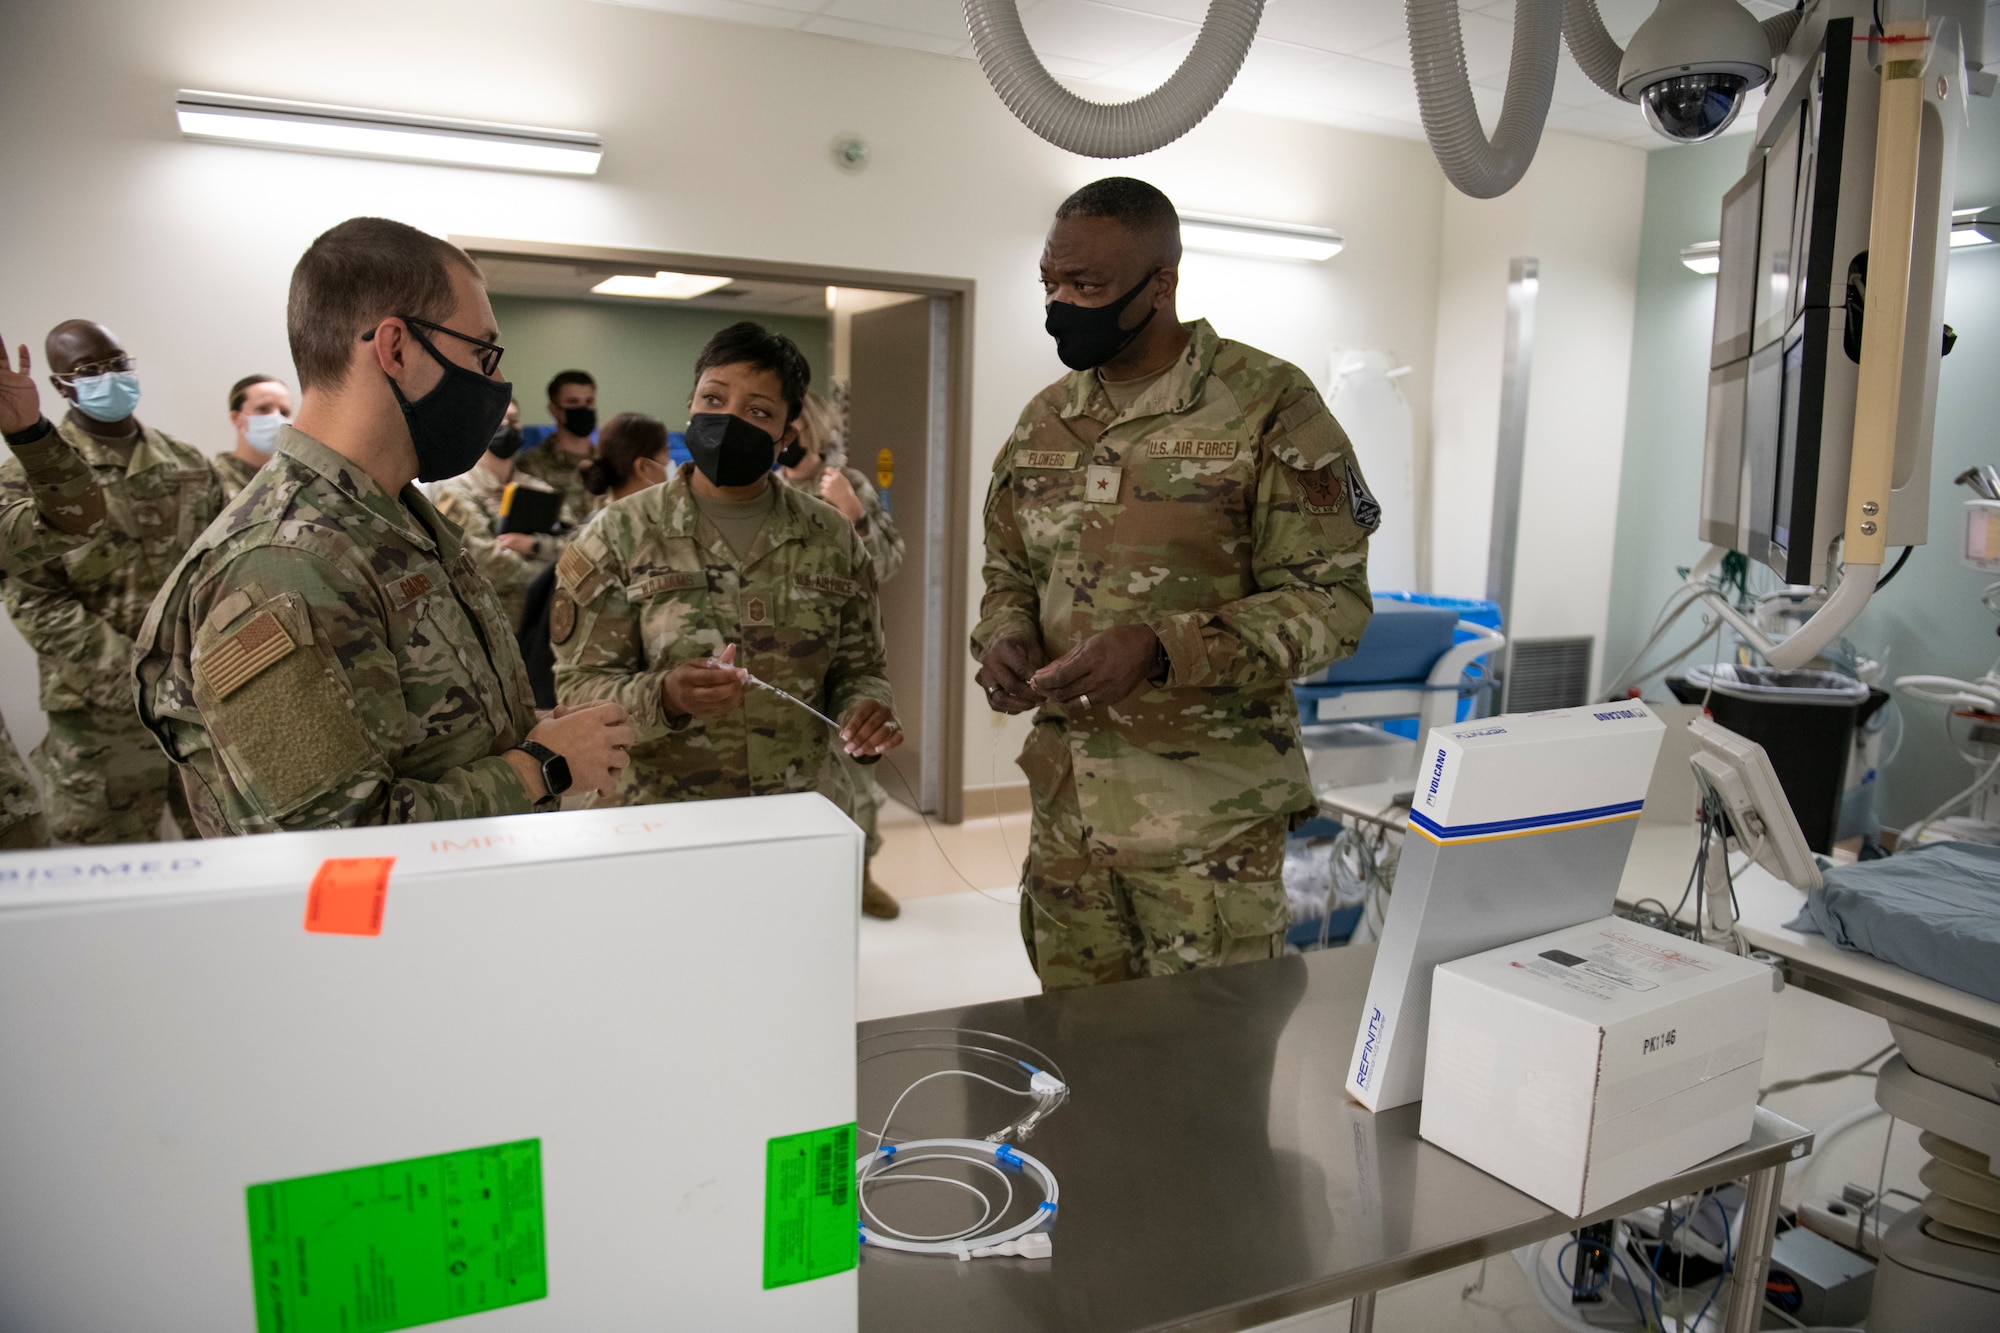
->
[1618, 0, 1770, 144]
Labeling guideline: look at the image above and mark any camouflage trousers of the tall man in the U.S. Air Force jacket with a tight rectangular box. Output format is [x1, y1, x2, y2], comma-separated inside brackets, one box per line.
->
[1020, 775, 1290, 991]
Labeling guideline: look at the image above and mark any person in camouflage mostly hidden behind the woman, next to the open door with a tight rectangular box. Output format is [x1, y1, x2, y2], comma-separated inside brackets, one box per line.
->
[778, 394, 906, 921]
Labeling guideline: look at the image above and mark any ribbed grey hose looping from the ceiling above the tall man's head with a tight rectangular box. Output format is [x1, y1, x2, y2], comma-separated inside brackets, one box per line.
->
[964, 0, 1264, 158]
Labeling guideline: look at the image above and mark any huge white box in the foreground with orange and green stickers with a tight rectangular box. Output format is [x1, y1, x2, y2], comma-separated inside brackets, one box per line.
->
[0, 795, 862, 1333]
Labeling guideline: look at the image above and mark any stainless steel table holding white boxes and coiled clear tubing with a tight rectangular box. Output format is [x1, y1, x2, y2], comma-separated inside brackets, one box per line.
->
[860, 947, 1812, 1333]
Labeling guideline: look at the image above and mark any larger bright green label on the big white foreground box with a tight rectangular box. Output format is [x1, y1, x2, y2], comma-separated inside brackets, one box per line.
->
[244, 1139, 552, 1333]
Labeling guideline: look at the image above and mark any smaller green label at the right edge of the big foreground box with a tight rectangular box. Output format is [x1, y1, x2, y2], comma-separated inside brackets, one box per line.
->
[764, 1123, 862, 1291]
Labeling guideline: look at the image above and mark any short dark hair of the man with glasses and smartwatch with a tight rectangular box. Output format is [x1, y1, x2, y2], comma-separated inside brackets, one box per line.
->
[284, 218, 480, 390]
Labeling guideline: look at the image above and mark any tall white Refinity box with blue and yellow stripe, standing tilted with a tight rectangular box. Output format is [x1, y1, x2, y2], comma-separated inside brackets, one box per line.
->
[1346, 703, 1666, 1111]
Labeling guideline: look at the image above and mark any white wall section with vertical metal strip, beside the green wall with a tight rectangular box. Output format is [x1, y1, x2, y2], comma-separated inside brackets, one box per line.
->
[1418, 134, 1646, 673]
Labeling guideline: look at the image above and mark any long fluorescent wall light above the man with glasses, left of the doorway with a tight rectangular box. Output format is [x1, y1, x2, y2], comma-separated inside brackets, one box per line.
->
[174, 90, 604, 176]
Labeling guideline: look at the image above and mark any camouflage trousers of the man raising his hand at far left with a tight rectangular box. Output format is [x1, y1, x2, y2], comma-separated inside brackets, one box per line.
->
[34, 709, 198, 843]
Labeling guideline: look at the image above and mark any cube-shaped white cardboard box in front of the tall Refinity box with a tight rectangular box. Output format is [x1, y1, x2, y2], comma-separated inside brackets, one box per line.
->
[1418, 917, 1770, 1217]
